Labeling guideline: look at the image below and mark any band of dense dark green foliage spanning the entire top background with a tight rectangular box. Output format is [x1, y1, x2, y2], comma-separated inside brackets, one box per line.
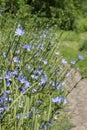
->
[0, 0, 87, 31]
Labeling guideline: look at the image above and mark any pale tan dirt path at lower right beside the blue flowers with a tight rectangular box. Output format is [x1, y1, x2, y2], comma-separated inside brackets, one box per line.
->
[68, 76, 87, 130]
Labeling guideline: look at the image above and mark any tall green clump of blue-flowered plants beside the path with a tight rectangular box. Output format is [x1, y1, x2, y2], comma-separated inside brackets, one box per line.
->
[0, 19, 75, 130]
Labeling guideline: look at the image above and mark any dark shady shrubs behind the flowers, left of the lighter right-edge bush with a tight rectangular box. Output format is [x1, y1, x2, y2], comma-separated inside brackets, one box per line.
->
[0, 0, 76, 30]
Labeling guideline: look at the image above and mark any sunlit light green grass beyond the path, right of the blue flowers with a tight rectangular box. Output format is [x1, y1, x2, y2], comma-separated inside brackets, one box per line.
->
[57, 31, 87, 78]
